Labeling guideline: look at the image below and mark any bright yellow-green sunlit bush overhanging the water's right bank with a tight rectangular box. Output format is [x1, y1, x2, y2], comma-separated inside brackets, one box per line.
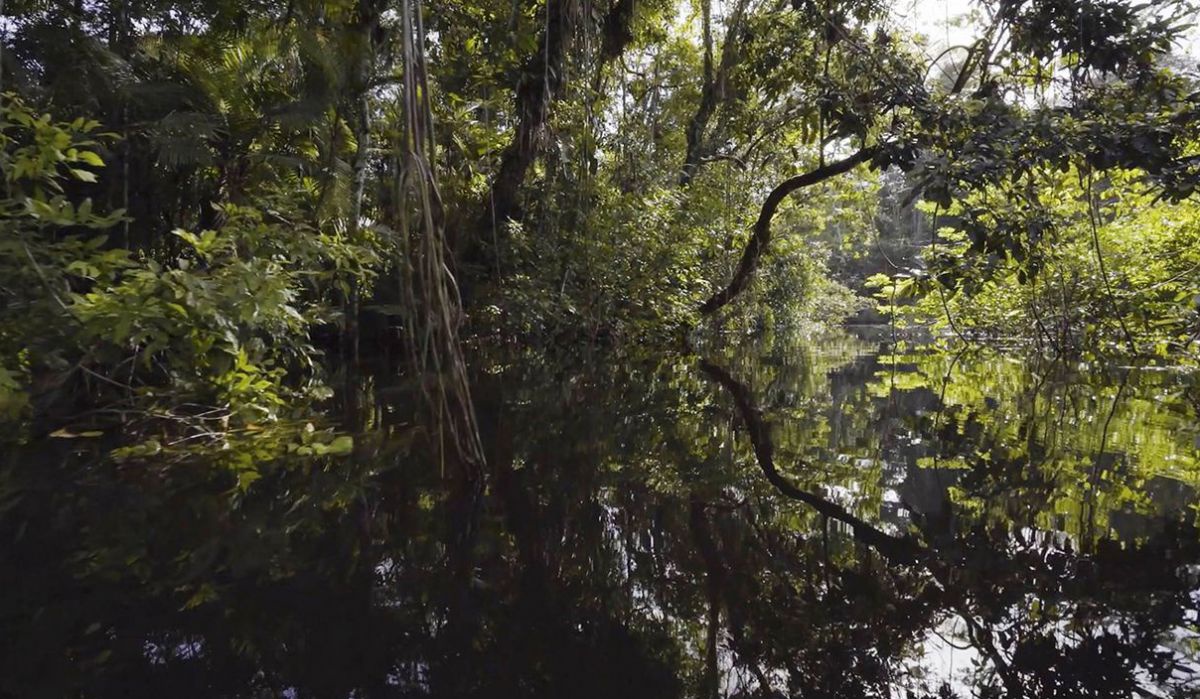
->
[874, 171, 1200, 360]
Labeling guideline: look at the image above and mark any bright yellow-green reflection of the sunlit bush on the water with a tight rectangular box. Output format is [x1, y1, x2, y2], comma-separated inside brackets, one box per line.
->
[871, 351, 1200, 534]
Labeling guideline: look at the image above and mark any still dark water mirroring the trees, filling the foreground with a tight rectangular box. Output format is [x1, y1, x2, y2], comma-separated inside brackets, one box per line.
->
[0, 334, 1200, 698]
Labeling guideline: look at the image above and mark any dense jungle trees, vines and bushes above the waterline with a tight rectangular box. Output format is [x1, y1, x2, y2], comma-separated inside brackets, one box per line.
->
[0, 0, 1200, 456]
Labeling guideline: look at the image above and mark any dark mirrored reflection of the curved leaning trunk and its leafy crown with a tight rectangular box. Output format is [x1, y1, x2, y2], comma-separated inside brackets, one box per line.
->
[701, 348, 1200, 697]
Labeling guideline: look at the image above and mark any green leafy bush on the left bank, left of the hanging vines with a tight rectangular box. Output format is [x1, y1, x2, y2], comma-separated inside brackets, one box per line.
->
[0, 95, 382, 466]
